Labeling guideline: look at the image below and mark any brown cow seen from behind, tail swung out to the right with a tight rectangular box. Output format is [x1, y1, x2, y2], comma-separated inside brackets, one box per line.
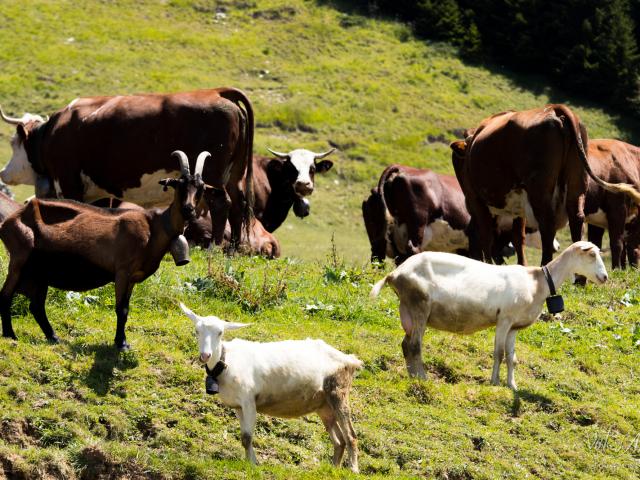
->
[451, 105, 640, 265]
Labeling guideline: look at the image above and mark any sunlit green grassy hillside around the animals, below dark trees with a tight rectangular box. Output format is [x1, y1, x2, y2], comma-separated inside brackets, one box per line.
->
[0, 0, 640, 480]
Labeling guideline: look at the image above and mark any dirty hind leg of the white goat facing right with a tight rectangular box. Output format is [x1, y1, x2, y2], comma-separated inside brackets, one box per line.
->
[400, 300, 431, 379]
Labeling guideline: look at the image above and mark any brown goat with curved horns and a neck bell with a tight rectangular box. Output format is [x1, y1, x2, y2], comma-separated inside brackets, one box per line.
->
[0, 151, 210, 350]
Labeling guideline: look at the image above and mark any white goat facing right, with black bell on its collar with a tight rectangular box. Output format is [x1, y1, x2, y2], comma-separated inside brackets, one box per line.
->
[371, 242, 607, 390]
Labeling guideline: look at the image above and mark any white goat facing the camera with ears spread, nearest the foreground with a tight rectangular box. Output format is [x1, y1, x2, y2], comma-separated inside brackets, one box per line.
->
[180, 303, 362, 473]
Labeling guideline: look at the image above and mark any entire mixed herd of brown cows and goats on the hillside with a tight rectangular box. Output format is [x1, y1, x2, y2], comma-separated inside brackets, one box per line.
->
[0, 88, 640, 471]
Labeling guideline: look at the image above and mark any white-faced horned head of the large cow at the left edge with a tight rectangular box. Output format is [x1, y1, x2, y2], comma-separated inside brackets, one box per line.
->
[0, 108, 48, 185]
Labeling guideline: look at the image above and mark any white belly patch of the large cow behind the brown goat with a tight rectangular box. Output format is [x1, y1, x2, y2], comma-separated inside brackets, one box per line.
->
[80, 170, 180, 208]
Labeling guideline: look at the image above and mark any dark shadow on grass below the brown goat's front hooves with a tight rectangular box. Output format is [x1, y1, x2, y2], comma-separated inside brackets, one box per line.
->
[71, 344, 138, 396]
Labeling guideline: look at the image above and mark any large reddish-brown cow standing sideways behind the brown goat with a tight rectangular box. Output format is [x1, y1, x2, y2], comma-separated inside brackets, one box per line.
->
[0, 88, 254, 249]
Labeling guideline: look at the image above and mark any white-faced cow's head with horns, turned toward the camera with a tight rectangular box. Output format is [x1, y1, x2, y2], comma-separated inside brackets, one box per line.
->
[267, 148, 335, 198]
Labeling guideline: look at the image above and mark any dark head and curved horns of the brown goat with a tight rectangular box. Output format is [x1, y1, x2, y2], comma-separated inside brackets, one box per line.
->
[158, 150, 211, 220]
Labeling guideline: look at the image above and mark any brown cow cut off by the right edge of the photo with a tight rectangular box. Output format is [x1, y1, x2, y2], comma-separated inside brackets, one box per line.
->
[584, 139, 640, 268]
